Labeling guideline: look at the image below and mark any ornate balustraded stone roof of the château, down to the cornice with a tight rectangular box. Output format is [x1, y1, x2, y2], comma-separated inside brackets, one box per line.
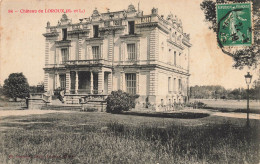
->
[43, 4, 190, 42]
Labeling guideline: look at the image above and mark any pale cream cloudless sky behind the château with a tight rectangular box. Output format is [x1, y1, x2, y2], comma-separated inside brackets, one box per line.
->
[0, 0, 256, 89]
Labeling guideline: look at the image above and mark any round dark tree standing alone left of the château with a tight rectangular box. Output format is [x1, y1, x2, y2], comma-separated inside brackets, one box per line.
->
[3, 73, 29, 101]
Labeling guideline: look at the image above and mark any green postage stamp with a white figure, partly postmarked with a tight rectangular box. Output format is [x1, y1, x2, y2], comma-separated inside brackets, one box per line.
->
[216, 3, 252, 47]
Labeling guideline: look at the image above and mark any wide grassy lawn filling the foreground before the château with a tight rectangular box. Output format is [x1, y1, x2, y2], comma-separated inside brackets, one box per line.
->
[0, 112, 260, 164]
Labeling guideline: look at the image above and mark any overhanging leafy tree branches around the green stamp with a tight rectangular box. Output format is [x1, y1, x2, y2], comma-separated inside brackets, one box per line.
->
[200, 0, 260, 69]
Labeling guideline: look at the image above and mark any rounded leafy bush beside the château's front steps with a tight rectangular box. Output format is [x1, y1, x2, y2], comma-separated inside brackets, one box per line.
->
[106, 90, 139, 113]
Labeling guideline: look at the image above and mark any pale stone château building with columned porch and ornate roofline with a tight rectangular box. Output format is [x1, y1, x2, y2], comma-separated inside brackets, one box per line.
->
[43, 5, 191, 108]
